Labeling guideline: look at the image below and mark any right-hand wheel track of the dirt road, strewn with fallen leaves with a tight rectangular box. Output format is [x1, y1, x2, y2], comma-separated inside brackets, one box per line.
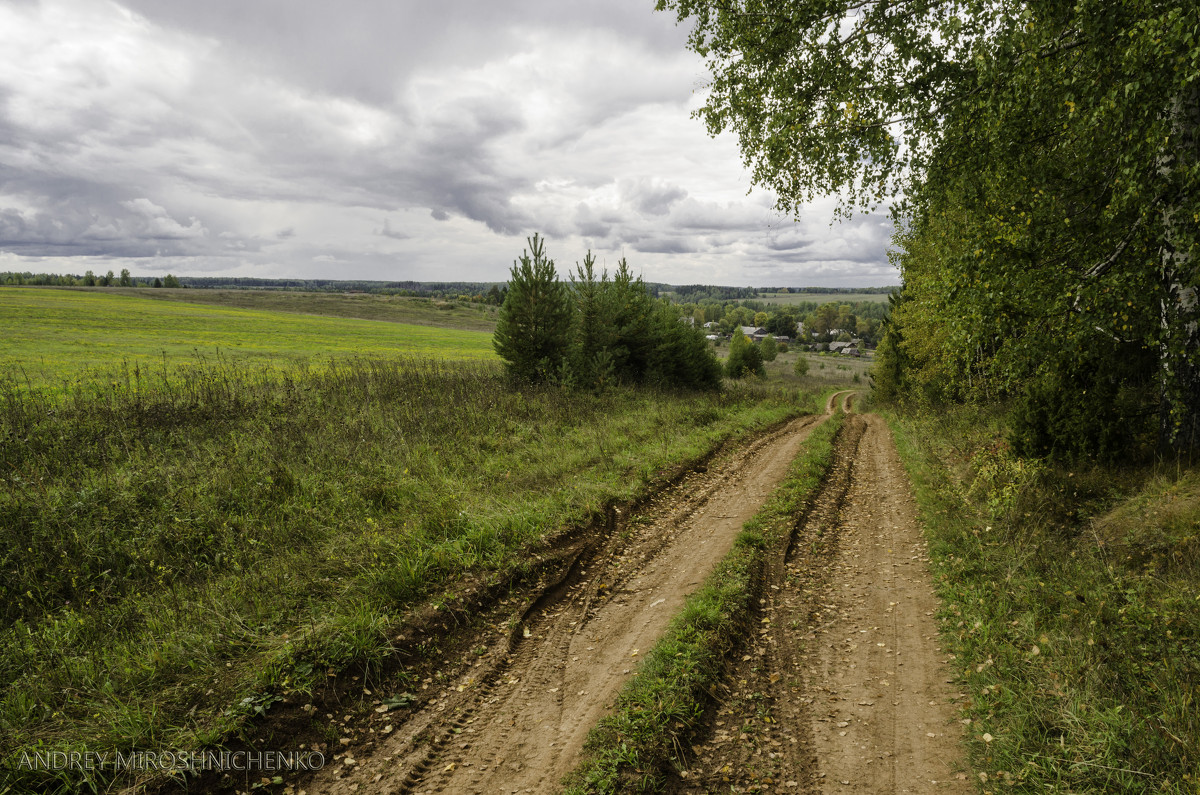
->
[670, 416, 970, 794]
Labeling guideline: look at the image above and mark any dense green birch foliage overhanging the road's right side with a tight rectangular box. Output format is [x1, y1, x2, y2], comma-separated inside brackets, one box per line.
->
[658, 0, 1200, 450]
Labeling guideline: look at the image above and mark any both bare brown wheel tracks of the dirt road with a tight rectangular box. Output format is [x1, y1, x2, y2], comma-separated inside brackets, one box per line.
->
[280, 393, 968, 795]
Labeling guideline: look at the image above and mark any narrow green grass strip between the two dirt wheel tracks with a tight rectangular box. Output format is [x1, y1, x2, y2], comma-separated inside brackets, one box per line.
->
[568, 410, 842, 795]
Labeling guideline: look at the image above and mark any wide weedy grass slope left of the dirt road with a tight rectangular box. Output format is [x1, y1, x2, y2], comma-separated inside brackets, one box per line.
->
[0, 359, 815, 791]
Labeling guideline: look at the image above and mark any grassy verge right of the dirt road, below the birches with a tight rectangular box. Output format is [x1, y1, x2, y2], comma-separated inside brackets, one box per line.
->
[889, 410, 1200, 794]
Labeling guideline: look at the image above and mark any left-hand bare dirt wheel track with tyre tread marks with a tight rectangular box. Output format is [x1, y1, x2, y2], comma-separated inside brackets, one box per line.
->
[306, 405, 840, 795]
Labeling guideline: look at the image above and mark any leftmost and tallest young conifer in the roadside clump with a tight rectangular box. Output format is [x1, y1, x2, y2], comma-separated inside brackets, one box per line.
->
[492, 234, 572, 382]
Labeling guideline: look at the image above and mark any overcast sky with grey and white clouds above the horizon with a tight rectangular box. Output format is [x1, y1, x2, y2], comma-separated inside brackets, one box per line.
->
[0, 0, 899, 286]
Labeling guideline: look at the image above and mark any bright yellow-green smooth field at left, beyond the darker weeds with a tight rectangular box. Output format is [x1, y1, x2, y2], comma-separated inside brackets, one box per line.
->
[0, 287, 496, 385]
